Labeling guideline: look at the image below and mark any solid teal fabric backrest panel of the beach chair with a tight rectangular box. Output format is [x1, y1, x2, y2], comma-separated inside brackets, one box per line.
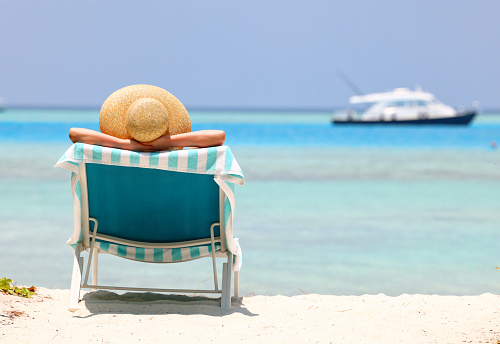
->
[85, 163, 220, 243]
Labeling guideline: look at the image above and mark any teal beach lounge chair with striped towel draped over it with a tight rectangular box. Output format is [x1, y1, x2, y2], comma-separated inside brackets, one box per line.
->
[56, 143, 244, 311]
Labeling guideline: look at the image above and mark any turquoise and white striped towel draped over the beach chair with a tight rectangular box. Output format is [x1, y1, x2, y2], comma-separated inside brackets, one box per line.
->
[55, 143, 245, 270]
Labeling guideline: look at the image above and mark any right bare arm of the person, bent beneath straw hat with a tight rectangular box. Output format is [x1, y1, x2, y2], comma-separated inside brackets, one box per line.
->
[146, 130, 226, 150]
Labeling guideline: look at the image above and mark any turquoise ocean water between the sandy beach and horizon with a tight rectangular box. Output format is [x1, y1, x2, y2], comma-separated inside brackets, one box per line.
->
[0, 110, 500, 295]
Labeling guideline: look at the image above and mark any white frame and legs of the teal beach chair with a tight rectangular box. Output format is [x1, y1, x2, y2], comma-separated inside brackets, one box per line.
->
[68, 163, 239, 311]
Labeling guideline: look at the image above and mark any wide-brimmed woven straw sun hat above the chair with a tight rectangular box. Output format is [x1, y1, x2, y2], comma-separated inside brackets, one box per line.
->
[99, 85, 191, 142]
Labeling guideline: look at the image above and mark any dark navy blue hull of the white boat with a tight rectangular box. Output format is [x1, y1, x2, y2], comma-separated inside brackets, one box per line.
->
[332, 111, 476, 125]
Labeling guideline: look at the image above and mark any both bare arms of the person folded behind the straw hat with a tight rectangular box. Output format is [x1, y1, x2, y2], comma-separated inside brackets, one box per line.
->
[69, 128, 226, 152]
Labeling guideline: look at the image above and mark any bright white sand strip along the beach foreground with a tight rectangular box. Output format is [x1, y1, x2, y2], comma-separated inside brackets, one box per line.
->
[0, 288, 500, 343]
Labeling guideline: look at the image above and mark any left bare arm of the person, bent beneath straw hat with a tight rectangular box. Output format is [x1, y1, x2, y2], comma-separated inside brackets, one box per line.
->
[69, 128, 155, 152]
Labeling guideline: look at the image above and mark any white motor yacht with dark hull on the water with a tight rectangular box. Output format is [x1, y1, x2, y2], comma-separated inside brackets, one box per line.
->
[332, 88, 476, 125]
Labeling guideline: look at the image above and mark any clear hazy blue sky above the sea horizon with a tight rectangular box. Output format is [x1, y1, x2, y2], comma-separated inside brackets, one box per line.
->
[0, 0, 500, 109]
